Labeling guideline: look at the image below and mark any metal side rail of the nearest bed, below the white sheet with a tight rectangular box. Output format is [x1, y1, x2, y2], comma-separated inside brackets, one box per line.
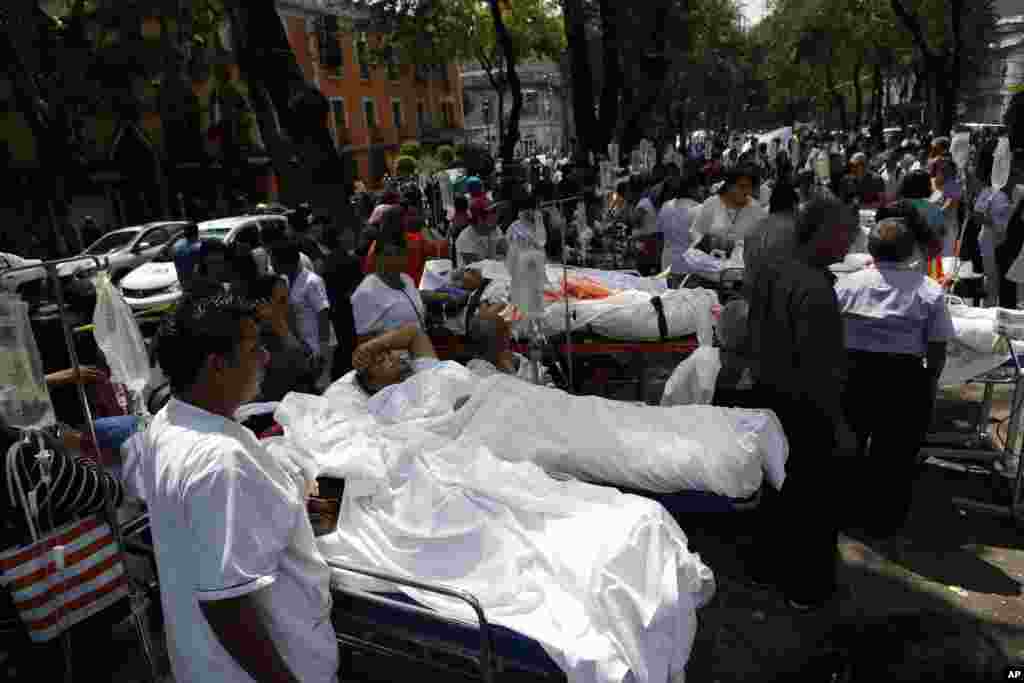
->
[327, 560, 497, 683]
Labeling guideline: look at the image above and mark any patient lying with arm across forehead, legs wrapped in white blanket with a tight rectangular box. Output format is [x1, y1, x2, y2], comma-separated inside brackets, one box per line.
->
[339, 328, 787, 499]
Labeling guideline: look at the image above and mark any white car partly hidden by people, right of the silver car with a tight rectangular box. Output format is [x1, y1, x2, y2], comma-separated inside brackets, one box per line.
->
[121, 215, 288, 310]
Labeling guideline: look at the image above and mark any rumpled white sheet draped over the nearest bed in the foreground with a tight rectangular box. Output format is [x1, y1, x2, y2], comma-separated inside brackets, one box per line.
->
[276, 385, 714, 683]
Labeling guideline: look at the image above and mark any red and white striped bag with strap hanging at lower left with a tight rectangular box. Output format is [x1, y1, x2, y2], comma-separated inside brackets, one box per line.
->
[0, 444, 130, 642]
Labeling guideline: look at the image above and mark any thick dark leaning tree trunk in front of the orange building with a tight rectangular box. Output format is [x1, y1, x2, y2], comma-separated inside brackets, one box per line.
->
[224, 0, 354, 228]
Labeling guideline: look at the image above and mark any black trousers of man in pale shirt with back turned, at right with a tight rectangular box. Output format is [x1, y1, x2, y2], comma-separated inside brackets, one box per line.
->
[843, 351, 935, 533]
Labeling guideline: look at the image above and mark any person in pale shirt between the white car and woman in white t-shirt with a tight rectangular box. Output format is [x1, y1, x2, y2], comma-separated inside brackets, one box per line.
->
[271, 237, 332, 373]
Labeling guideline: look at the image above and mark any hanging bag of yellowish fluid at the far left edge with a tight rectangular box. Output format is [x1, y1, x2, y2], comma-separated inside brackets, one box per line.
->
[0, 294, 56, 429]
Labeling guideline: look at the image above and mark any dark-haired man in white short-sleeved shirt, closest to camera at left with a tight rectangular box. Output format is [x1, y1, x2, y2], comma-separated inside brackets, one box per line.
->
[137, 294, 338, 683]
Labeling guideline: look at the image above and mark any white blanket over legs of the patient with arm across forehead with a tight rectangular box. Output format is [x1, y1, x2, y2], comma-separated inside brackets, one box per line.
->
[426, 376, 787, 498]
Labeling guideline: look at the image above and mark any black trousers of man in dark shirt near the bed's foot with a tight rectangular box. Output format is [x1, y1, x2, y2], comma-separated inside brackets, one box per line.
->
[749, 385, 842, 603]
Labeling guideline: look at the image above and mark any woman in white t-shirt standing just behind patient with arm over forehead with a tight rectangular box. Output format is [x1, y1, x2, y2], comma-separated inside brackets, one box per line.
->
[351, 214, 426, 339]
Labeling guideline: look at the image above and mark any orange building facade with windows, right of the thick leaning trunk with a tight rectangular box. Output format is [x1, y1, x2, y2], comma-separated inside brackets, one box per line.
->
[278, 0, 465, 186]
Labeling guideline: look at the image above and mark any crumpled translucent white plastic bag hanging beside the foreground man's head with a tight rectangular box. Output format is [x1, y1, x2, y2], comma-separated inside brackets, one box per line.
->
[92, 272, 151, 396]
